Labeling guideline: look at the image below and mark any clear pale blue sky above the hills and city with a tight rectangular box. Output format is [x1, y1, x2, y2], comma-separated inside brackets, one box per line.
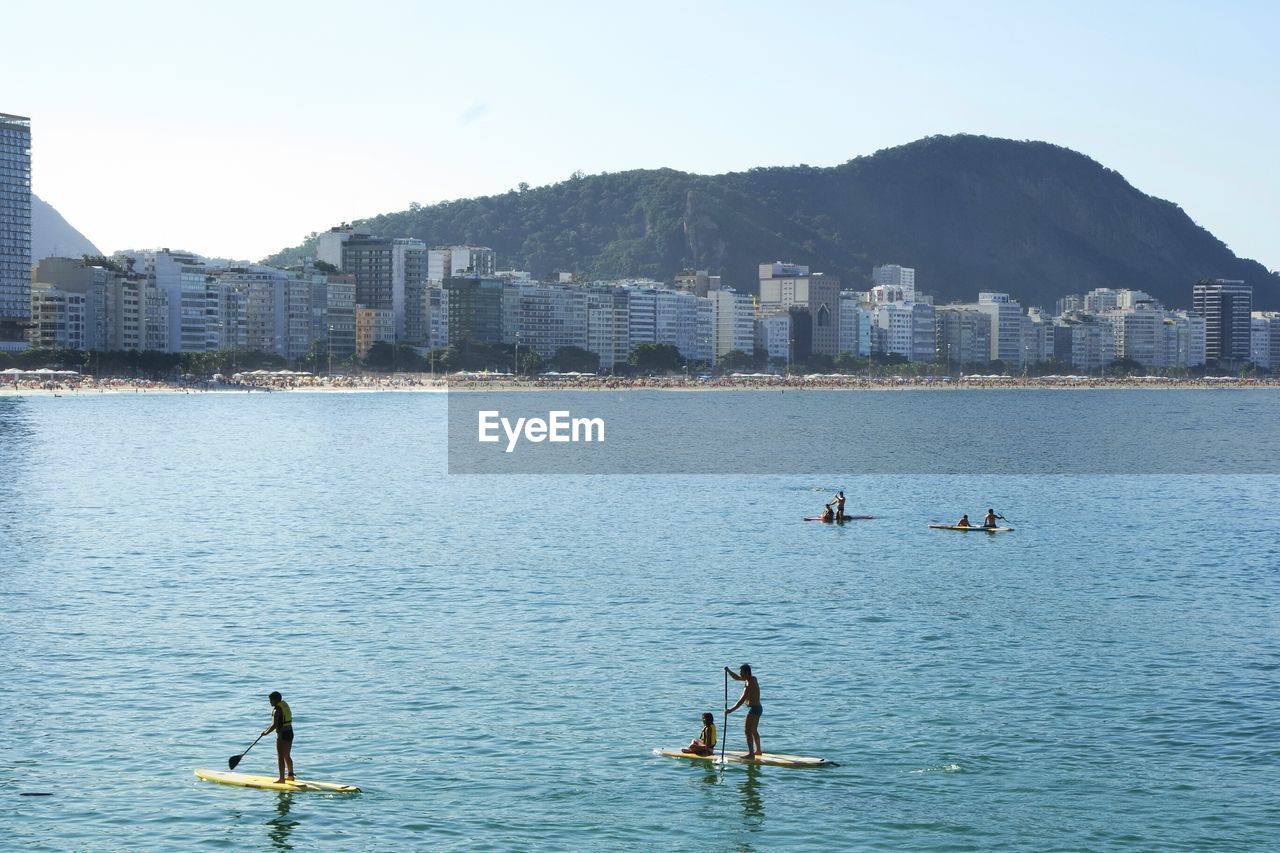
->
[0, 0, 1280, 269]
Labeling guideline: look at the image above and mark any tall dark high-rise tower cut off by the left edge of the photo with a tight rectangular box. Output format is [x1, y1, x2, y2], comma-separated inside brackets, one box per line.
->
[0, 113, 31, 347]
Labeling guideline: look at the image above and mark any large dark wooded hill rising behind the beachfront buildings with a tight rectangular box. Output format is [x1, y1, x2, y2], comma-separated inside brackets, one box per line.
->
[269, 136, 1280, 309]
